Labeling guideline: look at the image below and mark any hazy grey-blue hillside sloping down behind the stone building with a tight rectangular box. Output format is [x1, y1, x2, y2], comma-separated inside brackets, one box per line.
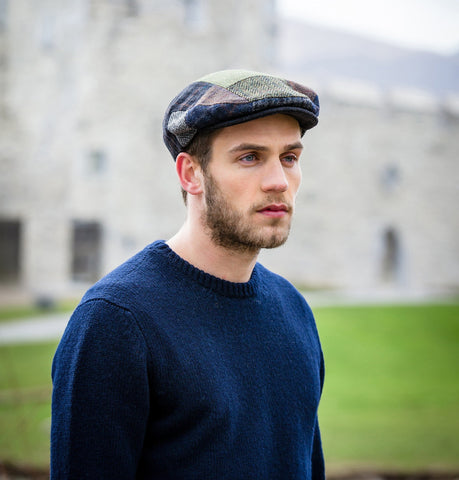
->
[277, 18, 459, 96]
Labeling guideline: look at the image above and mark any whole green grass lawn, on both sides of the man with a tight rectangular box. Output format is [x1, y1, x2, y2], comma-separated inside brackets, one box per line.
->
[0, 305, 459, 470]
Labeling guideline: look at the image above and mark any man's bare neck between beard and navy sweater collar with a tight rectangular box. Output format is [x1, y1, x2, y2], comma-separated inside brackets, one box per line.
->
[167, 218, 258, 283]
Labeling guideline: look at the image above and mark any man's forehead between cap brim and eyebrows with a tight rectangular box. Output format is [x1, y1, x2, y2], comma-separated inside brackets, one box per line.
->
[213, 114, 301, 147]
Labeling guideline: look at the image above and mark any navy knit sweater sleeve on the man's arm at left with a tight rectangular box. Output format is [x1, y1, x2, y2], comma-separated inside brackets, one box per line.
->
[51, 300, 149, 480]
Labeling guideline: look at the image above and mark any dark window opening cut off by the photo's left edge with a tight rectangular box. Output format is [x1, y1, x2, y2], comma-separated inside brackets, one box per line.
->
[0, 220, 21, 284]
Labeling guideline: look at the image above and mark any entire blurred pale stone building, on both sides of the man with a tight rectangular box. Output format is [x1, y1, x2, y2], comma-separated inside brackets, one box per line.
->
[0, 0, 459, 300]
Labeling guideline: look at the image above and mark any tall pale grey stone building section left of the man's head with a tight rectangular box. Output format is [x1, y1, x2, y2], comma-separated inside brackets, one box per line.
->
[0, 0, 274, 295]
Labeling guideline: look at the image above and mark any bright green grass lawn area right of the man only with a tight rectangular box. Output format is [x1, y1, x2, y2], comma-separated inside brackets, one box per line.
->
[315, 305, 459, 469]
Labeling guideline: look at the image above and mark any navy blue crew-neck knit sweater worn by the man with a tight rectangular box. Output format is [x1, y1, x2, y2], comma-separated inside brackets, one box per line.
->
[51, 241, 324, 480]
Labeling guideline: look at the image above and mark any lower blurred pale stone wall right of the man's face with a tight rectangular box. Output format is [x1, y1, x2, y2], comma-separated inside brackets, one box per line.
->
[262, 82, 459, 297]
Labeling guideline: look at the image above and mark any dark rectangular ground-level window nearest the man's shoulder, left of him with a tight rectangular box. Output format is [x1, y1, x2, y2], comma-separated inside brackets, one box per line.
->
[72, 221, 102, 282]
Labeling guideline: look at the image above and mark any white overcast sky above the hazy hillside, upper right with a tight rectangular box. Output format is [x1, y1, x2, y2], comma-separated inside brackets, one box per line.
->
[277, 0, 459, 55]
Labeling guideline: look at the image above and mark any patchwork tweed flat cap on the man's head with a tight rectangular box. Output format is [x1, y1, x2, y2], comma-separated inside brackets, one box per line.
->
[163, 70, 319, 160]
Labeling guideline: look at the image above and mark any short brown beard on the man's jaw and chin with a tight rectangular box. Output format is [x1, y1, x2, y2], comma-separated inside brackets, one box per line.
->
[202, 173, 291, 253]
